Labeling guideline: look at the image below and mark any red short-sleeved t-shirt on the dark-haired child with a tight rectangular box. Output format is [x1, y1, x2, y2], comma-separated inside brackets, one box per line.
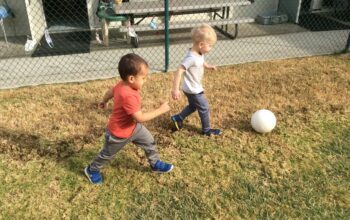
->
[107, 81, 141, 138]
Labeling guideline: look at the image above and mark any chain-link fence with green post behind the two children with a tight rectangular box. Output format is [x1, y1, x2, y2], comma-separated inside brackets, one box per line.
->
[0, 0, 350, 89]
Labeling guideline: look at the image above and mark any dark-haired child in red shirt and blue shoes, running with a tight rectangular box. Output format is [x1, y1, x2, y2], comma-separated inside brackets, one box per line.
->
[84, 53, 173, 184]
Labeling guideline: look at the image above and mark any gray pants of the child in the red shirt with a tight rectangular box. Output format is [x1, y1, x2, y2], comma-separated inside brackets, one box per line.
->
[90, 123, 159, 171]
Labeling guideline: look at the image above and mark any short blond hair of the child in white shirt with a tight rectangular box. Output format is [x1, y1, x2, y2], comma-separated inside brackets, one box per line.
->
[191, 24, 217, 43]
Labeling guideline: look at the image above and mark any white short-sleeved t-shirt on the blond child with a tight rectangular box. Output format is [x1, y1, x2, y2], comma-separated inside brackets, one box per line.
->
[181, 50, 204, 94]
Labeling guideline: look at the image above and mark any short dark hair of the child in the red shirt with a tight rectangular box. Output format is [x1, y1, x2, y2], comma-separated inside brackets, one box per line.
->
[118, 53, 148, 80]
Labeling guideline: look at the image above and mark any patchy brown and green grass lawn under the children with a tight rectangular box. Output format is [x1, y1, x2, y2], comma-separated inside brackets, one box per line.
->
[0, 55, 350, 219]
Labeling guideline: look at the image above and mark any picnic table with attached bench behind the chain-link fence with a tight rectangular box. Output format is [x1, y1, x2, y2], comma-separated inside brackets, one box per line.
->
[97, 0, 254, 47]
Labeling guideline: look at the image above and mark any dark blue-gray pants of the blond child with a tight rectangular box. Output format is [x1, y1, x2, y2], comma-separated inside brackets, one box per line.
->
[179, 92, 210, 133]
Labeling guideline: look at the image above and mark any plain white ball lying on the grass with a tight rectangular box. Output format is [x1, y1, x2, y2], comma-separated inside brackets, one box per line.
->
[250, 109, 277, 133]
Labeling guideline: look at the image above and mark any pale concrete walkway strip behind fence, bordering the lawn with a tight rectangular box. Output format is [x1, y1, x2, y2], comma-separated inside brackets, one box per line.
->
[0, 30, 350, 89]
